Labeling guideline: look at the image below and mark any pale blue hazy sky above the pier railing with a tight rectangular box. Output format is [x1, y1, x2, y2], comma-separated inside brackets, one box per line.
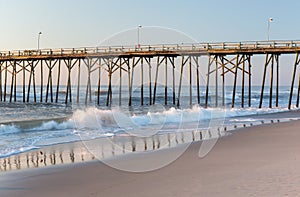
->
[0, 0, 300, 50]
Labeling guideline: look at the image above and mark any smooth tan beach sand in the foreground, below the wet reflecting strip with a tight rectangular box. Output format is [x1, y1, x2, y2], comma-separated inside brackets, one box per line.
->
[0, 121, 300, 197]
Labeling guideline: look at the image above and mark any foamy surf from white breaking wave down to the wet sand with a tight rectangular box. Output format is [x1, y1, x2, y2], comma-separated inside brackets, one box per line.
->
[0, 106, 298, 157]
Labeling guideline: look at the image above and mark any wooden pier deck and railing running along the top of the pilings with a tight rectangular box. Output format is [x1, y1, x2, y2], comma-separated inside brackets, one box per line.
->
[0, 40, 300, 59]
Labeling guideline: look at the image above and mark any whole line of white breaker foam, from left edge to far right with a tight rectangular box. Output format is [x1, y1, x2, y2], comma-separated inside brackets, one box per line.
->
[0, 106, 287, 135]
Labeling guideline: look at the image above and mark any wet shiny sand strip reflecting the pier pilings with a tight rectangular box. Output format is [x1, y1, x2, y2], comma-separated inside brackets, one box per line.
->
[0, 110, 300, 173]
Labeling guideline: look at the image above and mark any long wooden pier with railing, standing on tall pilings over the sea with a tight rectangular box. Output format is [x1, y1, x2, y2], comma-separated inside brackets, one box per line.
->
[0, 41, 300, 108]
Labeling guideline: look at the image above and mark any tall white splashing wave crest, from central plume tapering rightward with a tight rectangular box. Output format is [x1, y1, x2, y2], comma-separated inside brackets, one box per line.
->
[72, 106, 287, 129]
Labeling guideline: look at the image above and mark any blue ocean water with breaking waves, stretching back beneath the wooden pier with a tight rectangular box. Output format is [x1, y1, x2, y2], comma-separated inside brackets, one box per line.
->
[0, 86, 300, 158]
